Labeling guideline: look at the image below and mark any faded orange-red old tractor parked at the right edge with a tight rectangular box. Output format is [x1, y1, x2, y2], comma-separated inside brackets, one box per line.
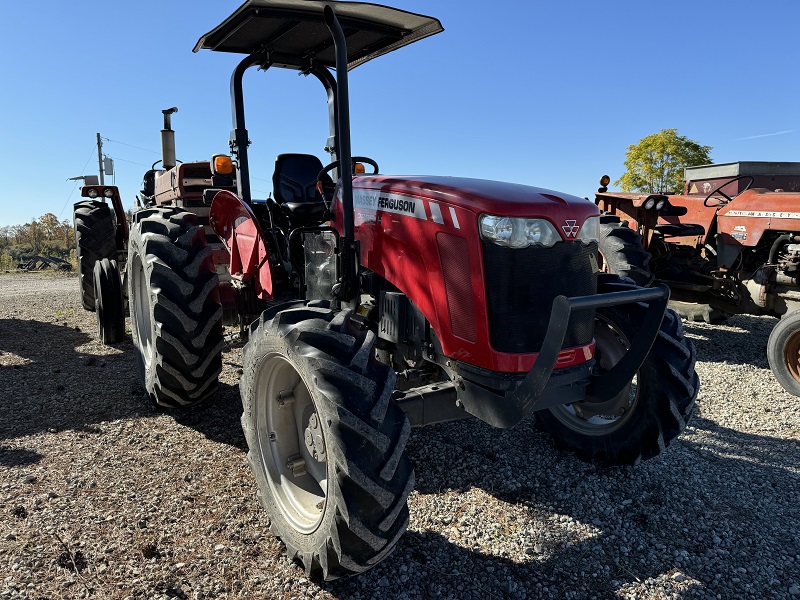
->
[596, 162, 800, 396]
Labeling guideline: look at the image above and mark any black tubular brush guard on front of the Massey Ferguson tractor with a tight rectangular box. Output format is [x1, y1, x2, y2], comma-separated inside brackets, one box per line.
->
[456, 285, 669, 428]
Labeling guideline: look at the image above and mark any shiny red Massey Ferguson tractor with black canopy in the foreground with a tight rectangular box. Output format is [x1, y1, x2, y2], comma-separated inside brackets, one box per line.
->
[78, 0, 698, 579]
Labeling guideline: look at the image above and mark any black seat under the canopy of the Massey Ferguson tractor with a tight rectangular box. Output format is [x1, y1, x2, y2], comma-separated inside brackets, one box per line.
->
[272, 154, 325, 222]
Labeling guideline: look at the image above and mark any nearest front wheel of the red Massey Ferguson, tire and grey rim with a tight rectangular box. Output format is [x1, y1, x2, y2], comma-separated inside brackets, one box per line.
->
[240, 306, 414, 580]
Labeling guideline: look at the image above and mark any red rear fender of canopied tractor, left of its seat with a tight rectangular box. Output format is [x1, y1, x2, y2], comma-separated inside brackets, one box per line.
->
[209, 190, 272, 300]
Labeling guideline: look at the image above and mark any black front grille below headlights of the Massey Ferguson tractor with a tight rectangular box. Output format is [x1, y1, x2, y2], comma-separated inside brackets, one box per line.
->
[483, 242, 597, 353]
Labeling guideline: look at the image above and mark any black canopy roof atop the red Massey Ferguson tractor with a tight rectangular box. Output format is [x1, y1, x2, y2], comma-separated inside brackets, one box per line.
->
[194, 0, 443, 70]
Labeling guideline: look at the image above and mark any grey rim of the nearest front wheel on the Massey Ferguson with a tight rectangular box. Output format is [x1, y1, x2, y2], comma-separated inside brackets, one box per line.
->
[253, 354, 328, 534]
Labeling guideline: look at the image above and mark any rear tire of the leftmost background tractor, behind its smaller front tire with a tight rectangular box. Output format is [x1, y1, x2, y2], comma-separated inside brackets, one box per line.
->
[72, 200, 117, 310]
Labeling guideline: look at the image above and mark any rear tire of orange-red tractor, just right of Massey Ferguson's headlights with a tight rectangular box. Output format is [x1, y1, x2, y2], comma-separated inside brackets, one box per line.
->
[598, 215, 653, 287]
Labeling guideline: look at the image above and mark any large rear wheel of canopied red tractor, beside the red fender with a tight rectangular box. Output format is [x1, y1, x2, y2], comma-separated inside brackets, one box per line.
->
[128, 208, 223, 408]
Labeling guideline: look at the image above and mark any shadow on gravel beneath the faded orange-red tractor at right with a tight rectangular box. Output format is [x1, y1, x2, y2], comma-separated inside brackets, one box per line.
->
[683, 315, 778, 369]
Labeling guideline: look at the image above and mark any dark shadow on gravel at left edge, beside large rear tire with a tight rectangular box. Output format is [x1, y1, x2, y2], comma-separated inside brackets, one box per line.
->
[0, 319, 151, 440]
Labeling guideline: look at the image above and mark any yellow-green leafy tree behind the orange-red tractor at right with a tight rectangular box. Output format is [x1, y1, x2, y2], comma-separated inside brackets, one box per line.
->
[614, 129, 711, 194]
